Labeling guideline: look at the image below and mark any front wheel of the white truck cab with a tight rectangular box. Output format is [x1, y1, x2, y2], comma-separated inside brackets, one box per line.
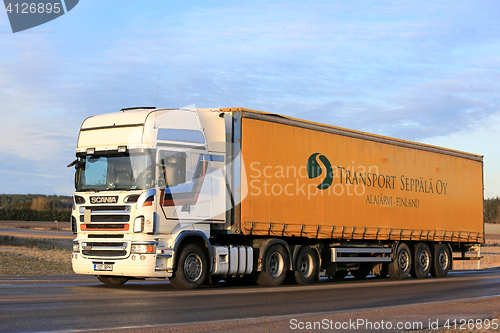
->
[169, 244, 208, 289]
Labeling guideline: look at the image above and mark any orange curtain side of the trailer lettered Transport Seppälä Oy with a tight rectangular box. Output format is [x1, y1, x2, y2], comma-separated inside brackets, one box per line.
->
[237, 110, 484, 243]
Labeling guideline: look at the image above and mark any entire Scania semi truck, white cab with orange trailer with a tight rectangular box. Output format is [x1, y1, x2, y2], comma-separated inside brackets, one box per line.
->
[69, 107, 484, 289]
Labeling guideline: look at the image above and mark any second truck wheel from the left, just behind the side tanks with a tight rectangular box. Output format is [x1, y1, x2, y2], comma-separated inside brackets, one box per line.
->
[256, 244, 290, 286]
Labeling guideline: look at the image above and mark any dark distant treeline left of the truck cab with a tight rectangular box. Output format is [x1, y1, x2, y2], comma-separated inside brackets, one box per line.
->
[0, 194, 73, 221]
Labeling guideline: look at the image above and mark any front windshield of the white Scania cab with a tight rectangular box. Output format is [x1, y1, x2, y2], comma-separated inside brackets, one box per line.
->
[75, 149, 155, 191]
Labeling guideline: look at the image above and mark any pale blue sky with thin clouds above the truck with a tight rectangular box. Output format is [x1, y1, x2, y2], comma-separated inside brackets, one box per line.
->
[0, 0, 500, 197]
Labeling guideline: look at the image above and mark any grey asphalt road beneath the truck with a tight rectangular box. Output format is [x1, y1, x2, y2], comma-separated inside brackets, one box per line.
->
[0, 269, 500, 332]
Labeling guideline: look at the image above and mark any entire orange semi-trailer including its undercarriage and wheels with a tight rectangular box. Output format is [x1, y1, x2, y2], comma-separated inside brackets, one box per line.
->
[213, 109, 484, 284]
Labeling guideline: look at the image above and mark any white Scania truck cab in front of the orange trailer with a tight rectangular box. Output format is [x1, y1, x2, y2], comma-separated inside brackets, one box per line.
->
[71, 108, 234, 284]
